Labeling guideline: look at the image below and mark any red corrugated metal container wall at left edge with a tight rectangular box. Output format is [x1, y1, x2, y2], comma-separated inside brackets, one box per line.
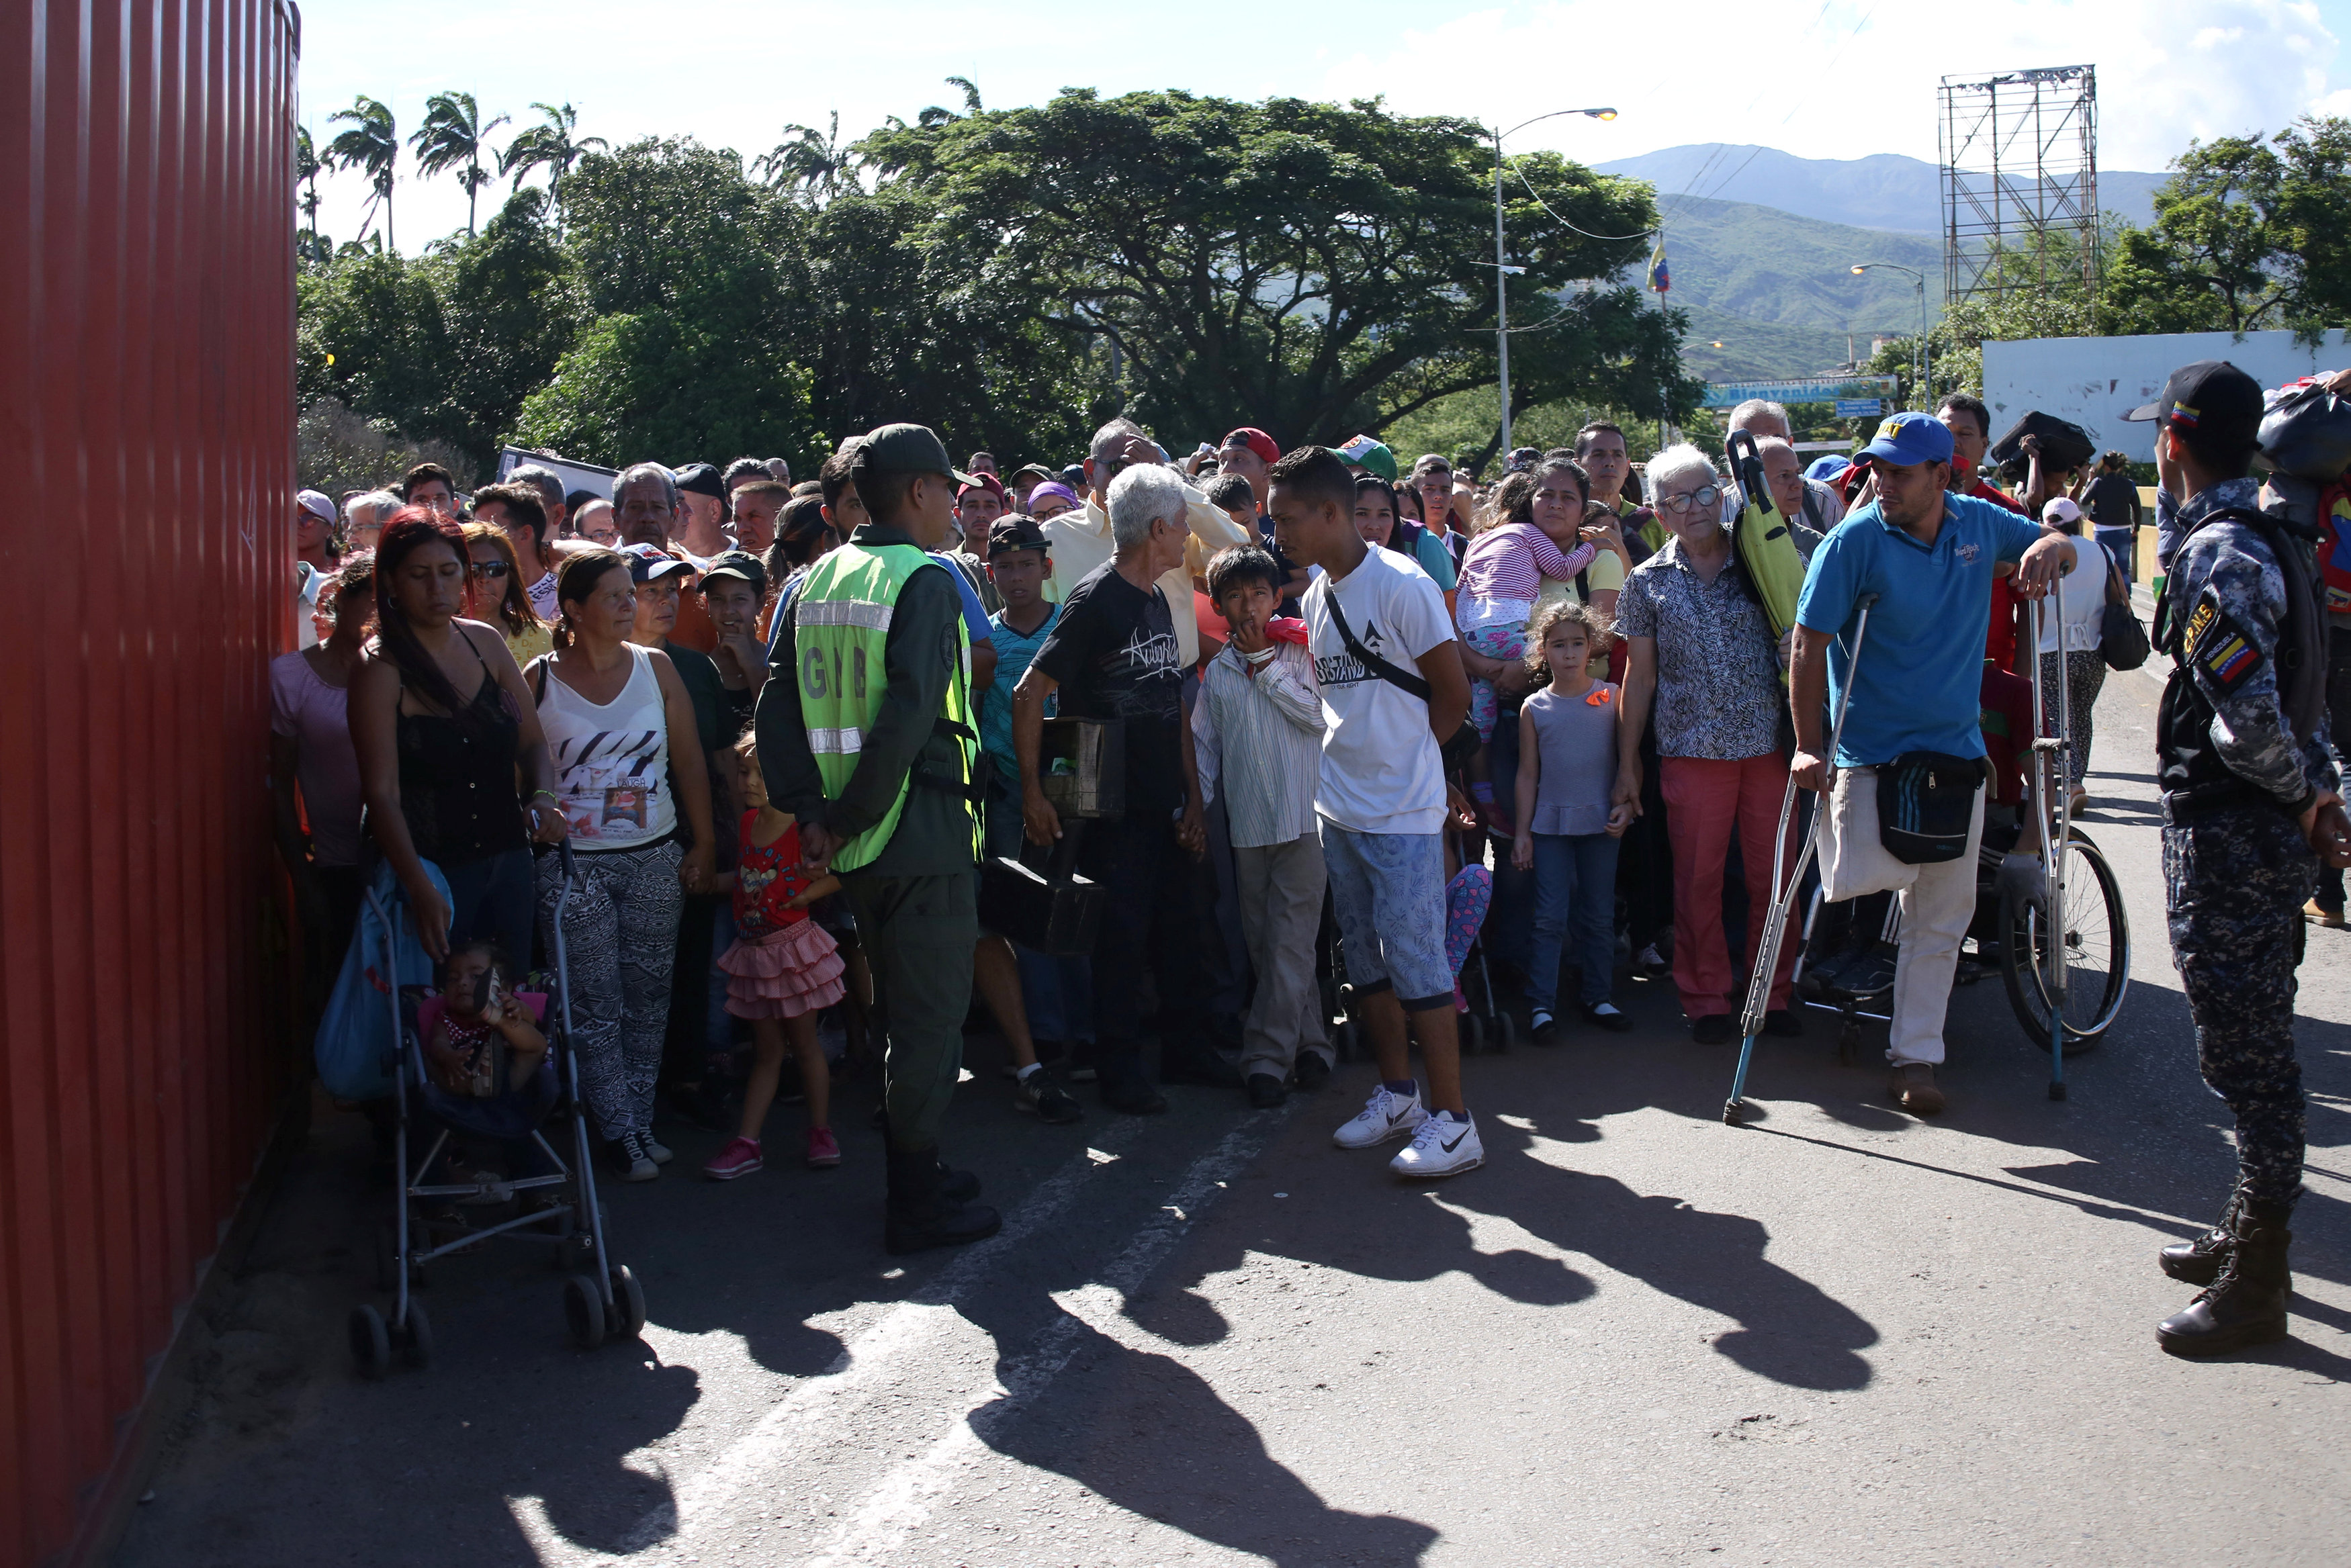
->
[0, 0, 299, 1561]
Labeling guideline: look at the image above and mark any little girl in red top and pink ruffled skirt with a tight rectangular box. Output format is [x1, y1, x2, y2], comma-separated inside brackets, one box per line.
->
[703, 736, 846, 1183]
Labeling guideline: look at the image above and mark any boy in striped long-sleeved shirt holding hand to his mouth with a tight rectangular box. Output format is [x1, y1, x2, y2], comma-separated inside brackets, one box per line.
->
[1192, 545, 1333, 1109]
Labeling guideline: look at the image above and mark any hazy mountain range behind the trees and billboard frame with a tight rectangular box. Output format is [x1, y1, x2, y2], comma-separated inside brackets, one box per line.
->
[1597, 144, 2170, 381]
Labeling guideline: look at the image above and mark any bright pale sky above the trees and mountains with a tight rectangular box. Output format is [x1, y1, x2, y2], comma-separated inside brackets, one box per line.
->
[301, 0, 2351, 252]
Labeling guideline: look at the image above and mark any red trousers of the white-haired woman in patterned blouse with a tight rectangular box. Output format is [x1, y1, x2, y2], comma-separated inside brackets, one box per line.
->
[1658, 752, 1796, 1018]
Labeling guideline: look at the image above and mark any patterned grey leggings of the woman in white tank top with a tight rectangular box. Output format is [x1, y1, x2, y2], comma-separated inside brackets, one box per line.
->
[539, 839, 686, 1138]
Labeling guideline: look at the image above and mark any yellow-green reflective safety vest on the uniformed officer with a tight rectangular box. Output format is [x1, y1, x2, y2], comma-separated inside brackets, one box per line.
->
[793, 543, 981, 872]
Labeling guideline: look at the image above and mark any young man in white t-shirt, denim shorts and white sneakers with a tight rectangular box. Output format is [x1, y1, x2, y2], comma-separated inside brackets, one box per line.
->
[1270, 447, 1486, 1175]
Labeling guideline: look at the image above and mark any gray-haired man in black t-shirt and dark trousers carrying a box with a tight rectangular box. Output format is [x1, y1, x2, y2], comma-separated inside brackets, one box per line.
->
[1014, 461, 1241, 1117]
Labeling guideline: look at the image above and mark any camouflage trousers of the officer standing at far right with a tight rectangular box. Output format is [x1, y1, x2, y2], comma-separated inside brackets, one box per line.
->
[2163, 804, 2318, 1203]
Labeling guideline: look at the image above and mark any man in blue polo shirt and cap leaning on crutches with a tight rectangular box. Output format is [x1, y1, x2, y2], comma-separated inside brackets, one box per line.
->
[1789, 414, 2074, 1114]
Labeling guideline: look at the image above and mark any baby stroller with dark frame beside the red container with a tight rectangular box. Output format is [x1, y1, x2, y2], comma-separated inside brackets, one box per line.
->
[351, 844, 644, 1377]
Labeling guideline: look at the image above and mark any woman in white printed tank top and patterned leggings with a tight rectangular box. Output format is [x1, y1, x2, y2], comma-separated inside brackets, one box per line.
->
[529, 550, 713, 1183]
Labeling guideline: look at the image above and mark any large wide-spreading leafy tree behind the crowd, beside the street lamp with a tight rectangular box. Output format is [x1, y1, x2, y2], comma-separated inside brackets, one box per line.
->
[858, 89, 1697, 442]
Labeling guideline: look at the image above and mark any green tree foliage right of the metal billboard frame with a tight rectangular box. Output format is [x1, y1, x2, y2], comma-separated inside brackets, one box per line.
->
[2100, 116, 2351, 336]
